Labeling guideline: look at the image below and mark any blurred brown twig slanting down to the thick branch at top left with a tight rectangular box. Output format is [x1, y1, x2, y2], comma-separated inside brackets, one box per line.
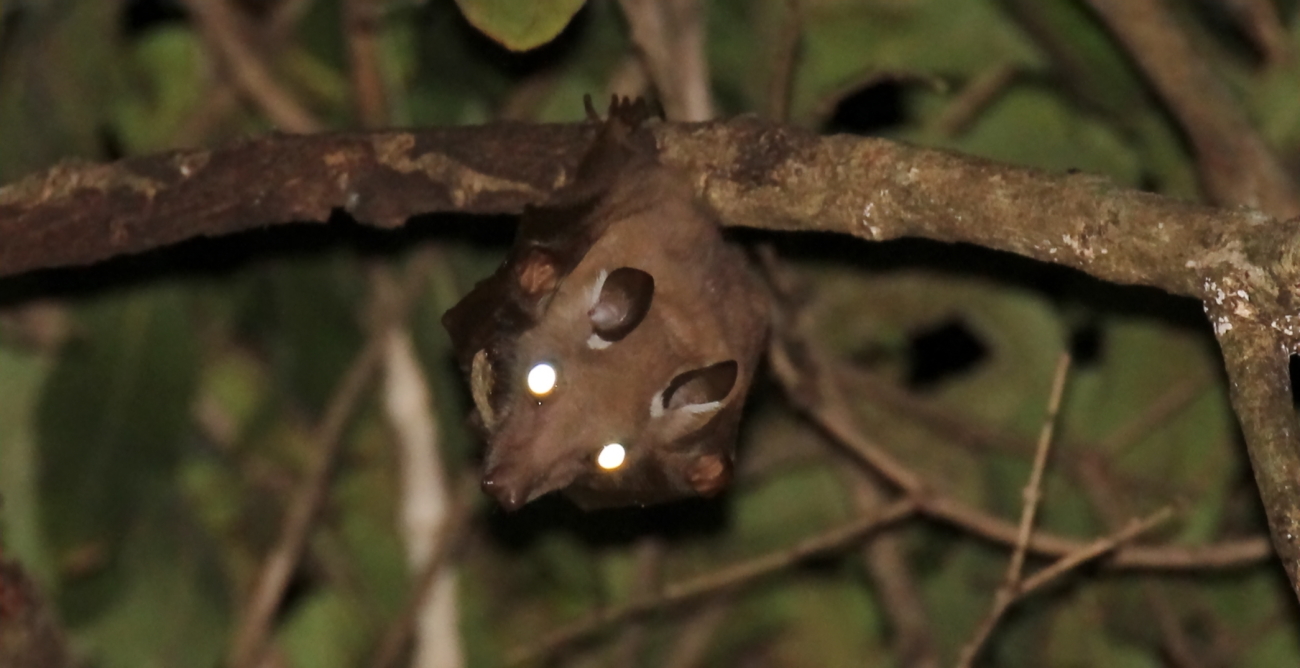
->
[182, 0, 325, 134]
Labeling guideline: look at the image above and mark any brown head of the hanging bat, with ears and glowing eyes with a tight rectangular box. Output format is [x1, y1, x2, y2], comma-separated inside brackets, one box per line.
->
[476, 250, 742, 508]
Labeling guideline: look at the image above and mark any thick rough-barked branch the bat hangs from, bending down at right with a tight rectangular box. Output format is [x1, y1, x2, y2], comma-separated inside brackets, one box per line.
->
[0, 118, 1300, 594]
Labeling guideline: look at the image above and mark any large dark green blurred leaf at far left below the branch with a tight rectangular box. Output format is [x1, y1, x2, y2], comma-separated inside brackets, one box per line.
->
[36, 289, 198, 621]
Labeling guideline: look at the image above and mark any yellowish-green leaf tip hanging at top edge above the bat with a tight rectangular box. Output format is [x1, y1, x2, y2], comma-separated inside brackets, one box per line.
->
[456, 0, 585, 51]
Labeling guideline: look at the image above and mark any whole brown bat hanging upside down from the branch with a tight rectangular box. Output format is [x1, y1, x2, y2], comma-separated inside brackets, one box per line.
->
[442, 97, 768, 511]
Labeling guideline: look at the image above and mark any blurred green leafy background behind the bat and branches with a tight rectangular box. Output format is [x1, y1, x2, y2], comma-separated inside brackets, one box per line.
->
[0, 0, 1300, 668]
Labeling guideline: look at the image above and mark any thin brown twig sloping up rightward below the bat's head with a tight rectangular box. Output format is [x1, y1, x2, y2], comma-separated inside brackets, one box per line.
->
[507, 499, 917, 665]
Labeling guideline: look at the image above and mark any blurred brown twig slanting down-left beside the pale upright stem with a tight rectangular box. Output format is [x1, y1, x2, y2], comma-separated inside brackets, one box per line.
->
[228, 335, 384, 668]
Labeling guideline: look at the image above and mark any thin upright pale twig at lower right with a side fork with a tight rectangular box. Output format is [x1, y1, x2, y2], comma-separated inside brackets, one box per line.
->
[958, 353, 1070, 667]
